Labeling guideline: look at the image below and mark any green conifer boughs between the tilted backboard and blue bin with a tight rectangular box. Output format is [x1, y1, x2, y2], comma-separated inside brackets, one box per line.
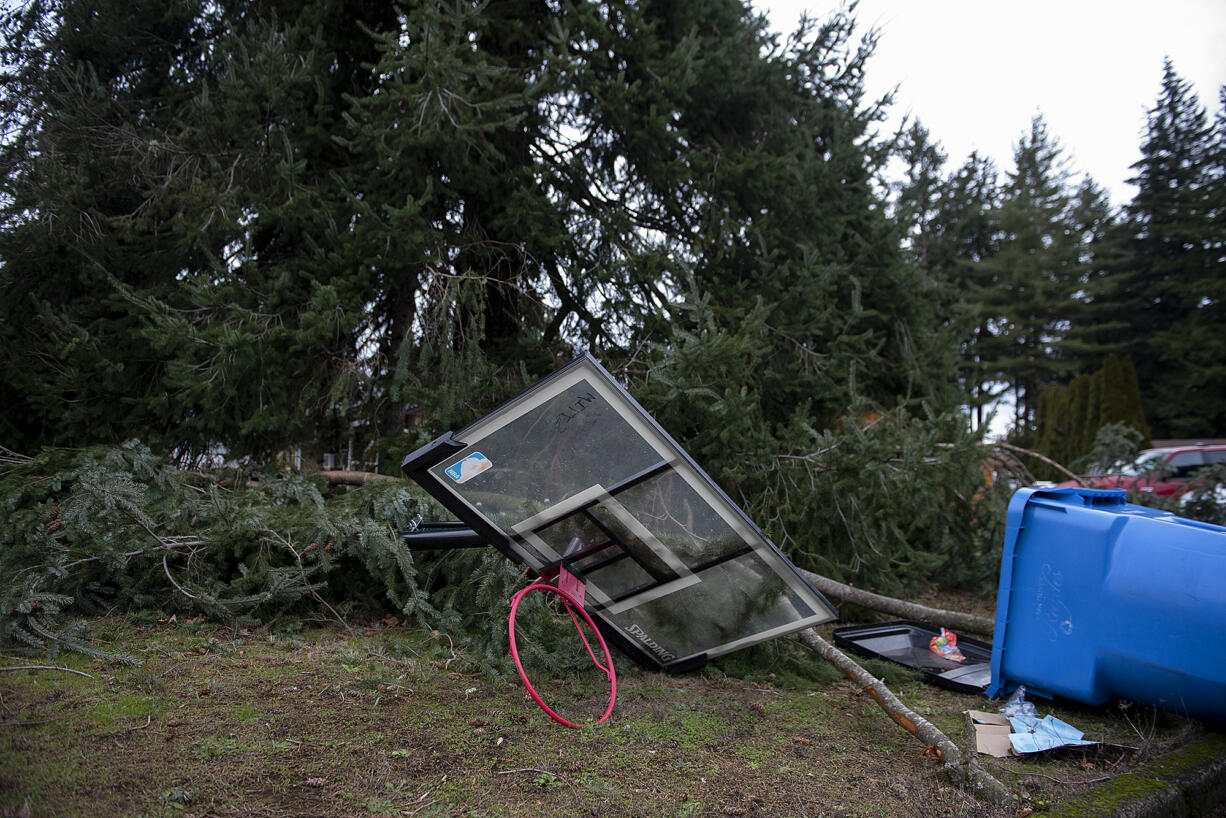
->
[636, 298, 1004, 592]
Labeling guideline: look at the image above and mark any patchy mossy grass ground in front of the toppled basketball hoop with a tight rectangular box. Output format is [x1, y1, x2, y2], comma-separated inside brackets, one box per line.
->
[0, 618, 1200, 817]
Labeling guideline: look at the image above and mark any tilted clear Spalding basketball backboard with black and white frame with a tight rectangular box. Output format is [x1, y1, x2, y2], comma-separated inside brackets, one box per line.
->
[403, 356, 837, 671]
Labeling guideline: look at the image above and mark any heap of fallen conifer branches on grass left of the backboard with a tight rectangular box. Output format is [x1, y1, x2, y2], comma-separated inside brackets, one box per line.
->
[0, 441, 446, 652]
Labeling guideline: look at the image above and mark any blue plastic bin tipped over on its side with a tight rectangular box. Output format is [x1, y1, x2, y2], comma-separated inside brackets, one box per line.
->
[987, 488, 1226, 722]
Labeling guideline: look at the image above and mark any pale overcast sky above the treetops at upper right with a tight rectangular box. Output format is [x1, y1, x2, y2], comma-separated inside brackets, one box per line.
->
[752, 0, 1226, 205]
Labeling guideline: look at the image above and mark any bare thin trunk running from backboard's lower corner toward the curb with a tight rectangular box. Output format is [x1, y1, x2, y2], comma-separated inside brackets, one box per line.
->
[799, 628, 1010, 805]
